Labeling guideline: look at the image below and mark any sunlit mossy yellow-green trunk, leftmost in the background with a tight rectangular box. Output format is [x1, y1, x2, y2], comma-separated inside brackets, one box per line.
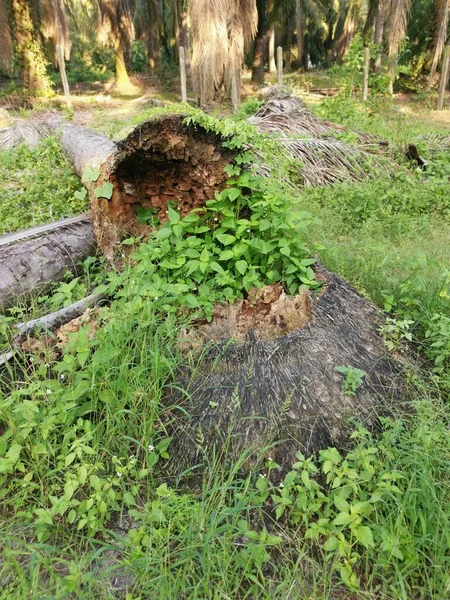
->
[11, 0, 51, 93]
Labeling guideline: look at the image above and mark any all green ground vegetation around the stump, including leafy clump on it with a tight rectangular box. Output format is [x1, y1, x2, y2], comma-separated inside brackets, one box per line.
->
[0, 85, 450, 600]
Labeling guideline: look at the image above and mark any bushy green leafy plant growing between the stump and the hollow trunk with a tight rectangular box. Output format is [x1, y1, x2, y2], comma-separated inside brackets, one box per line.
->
[111, 162, 319, 317]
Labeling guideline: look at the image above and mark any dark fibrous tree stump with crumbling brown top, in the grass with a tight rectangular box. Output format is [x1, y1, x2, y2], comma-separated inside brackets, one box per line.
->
[166, 269, 404, 474]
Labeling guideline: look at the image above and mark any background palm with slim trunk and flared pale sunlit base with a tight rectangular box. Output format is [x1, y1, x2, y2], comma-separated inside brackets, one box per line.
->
[97, 0, 134, 88]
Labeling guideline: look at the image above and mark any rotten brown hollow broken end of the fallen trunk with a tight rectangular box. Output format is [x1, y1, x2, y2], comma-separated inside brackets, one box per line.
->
[91, 115, 234, 256]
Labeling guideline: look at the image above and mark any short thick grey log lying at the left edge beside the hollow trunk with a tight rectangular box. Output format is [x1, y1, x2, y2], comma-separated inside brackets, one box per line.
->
[0, 215, 96, 314]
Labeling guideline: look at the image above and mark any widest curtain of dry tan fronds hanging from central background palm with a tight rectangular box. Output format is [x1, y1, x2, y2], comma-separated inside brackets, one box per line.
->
[190, 0, 258, 105]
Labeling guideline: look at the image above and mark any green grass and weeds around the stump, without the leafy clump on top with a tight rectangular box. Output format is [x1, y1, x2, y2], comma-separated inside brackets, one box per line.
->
[0, 92, 450, 600]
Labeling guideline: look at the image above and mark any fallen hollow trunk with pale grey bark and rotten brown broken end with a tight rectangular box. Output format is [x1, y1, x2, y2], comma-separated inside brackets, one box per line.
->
[40, 114, 234, 260]
